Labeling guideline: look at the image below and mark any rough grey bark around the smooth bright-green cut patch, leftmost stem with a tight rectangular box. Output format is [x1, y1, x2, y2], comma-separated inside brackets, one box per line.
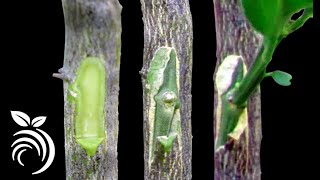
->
[59, 0, 121, 179]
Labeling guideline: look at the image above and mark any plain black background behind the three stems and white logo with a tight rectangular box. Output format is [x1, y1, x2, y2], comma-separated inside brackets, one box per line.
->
[1, 0, 320, 180]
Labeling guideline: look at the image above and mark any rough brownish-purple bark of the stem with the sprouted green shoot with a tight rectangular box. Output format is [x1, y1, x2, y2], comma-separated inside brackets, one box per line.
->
[214, 0, 262, 180]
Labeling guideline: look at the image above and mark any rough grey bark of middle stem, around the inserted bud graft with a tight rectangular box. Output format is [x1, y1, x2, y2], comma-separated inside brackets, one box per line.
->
[141, 0, 192, 180]
